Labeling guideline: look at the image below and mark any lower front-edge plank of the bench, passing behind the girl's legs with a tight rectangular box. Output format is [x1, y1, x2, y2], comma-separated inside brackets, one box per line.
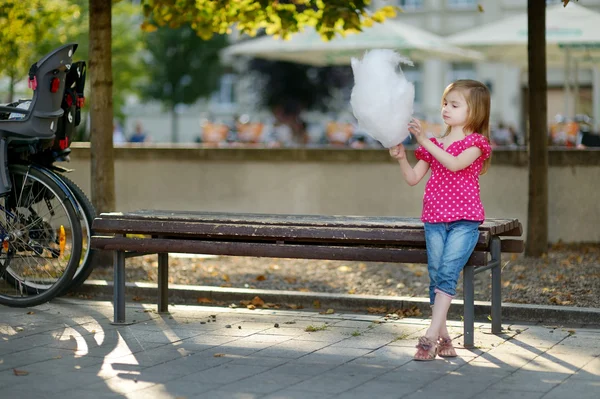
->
[92, 236, 488, 266]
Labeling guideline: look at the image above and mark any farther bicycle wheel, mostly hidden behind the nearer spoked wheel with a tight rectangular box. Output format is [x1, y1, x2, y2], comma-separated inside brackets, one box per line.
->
[57, 174, 98, 294]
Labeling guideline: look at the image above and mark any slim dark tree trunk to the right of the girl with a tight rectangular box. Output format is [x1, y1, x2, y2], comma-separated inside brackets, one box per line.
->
[525, 0, 548, 257]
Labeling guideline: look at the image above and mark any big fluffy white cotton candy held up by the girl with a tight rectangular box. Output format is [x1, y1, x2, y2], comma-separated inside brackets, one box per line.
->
[350, 49, 415, 148]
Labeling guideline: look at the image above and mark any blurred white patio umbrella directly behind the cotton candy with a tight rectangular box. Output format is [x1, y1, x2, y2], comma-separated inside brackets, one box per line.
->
[222, 19, 484, 66]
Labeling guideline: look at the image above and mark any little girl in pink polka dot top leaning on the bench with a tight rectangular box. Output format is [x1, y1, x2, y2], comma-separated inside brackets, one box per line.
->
[390, 80, 492, 360]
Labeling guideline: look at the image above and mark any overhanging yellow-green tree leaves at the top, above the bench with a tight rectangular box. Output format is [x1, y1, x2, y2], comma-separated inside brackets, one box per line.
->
[142, 0, 399, 40]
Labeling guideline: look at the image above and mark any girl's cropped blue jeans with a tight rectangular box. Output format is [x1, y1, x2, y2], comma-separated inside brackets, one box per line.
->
[425, 220, 481, 305]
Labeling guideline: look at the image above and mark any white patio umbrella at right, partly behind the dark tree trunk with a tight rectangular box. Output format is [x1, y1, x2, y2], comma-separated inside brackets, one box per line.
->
[447, 2, 600, 66]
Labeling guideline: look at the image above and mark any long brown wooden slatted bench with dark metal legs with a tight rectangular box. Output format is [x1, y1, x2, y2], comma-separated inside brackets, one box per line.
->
[91, 210, 523, 347]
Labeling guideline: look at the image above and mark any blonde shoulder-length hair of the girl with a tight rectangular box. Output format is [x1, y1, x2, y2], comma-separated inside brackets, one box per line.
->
[442, 79, 492, 175]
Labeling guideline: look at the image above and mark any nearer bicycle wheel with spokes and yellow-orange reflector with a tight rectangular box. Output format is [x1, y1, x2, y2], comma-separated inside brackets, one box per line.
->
[0, 165, 82, 307]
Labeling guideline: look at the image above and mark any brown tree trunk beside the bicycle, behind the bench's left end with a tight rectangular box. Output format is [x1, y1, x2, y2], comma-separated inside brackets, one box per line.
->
[89, 0, 115, 212]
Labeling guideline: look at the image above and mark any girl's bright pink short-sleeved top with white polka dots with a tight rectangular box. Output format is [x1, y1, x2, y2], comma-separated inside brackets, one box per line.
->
[415, 133, 492, 223]
